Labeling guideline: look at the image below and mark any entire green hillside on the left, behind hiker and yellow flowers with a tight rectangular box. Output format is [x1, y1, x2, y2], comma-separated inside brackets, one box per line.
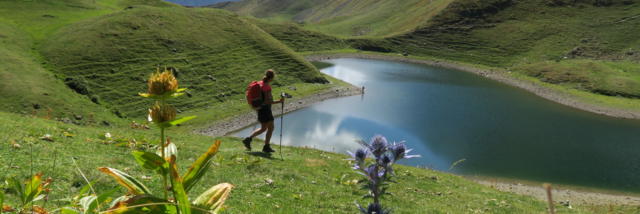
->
[0, 0, 327, 121]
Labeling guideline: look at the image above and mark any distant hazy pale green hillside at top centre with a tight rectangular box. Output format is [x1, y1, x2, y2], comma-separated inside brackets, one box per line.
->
[214, 0, 452, 38]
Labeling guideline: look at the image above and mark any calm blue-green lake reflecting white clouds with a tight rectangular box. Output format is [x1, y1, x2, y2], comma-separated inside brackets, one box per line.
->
[234, 59, 640, 192]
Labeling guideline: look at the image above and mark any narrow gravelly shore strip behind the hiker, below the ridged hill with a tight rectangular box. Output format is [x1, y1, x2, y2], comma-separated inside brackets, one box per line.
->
[196, 86, 362, 137]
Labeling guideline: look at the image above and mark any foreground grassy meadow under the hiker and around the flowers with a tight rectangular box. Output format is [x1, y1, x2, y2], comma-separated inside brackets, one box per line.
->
[0, 112, 633, 213]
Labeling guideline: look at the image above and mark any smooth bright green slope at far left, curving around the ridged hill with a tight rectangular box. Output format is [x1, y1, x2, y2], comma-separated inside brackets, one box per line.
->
[0, 0, 178, 124]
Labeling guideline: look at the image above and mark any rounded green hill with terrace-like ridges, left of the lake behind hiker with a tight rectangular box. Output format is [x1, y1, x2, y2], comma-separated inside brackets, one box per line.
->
[41, 7, 326, 116]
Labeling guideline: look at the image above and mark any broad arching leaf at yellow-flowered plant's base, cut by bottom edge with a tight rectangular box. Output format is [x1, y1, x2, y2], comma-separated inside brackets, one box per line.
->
[104, 195, 178, 214]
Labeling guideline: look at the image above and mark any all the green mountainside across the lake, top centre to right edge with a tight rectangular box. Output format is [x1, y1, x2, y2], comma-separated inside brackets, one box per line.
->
[218, 0, 640, 101]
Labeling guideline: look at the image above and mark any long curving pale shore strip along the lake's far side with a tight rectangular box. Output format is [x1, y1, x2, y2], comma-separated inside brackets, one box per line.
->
[305, 53, 640, 119]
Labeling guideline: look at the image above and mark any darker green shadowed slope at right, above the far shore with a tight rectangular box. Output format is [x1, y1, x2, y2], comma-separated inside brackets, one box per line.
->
[381, 0, 640, 98]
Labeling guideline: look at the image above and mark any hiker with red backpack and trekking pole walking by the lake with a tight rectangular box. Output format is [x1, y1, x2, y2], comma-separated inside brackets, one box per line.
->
[242, 69, 284, 153]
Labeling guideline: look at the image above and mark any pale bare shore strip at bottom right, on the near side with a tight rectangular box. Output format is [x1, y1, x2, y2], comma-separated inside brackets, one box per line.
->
[467, 177, 640, 206]
